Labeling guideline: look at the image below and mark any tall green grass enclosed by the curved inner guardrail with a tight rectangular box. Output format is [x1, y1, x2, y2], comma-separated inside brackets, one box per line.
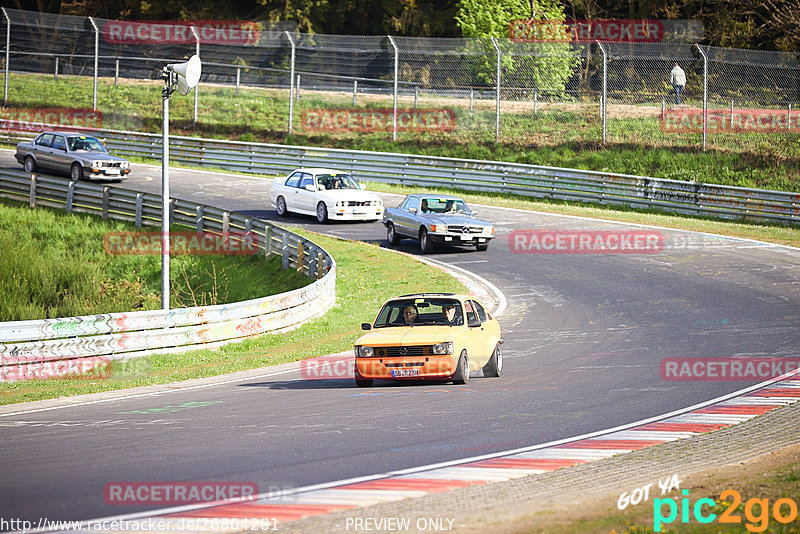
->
[0, 200, 309, 321]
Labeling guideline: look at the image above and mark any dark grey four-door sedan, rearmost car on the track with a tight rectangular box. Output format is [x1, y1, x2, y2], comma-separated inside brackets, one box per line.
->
[15, 132, 131, 180]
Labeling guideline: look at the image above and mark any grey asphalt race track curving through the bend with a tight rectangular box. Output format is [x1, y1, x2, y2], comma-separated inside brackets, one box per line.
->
[0, 150, 800, 521]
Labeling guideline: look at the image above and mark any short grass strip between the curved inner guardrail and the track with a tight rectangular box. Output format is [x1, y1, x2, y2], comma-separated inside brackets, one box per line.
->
[0, 228, 465, 404]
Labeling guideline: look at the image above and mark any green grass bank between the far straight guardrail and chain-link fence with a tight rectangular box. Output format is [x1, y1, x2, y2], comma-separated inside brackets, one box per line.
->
[3, 74, 800, 195]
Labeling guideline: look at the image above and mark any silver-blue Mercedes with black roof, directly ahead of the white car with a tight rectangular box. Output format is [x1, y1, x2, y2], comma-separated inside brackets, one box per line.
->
[383, 195, 494, 253]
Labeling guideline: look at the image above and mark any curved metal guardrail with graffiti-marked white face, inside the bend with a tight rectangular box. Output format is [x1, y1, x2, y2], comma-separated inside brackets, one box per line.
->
[0, 170, 336, 374]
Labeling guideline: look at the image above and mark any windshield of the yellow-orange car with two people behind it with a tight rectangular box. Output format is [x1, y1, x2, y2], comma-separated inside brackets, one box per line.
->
[375, 298, 464, 328]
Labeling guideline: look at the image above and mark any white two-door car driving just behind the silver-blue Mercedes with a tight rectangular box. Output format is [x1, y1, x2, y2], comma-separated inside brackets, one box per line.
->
[270, 169, 383, 223]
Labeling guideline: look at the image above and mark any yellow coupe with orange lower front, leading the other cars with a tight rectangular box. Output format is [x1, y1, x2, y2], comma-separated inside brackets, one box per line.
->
[354, 293, 503, 387]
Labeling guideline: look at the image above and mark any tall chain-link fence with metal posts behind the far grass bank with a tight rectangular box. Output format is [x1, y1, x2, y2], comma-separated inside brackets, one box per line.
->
[0, 8, 800, 151]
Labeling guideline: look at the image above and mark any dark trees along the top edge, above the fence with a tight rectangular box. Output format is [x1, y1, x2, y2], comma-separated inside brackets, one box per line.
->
[7, 0, 800, 52]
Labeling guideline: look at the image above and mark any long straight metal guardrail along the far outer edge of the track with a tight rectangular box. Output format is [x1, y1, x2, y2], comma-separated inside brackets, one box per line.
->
[0, 130, 800, 224]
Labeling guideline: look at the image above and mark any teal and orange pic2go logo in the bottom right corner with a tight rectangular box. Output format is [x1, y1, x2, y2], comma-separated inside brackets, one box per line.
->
[653, 489, 797, 532]
